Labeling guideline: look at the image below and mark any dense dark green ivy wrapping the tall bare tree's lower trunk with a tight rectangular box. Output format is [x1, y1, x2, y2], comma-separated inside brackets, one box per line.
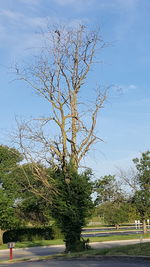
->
[51, 170, 94, 252]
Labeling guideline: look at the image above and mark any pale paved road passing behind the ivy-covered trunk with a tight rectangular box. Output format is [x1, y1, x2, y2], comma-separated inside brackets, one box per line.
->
[0, 239, 150, 260]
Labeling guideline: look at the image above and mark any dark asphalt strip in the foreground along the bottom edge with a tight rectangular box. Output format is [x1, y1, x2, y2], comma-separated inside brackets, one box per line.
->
[1, 257, 150, 267]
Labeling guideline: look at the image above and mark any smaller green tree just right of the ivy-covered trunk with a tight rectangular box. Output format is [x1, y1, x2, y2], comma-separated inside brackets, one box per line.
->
[95, 175, 132, 229]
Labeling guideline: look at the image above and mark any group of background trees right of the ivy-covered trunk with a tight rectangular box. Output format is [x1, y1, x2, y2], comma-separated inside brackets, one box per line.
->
[95, 151, 150, 233]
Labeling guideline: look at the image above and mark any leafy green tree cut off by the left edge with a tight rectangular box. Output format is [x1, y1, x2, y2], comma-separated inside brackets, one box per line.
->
[0, 145, 22, 244]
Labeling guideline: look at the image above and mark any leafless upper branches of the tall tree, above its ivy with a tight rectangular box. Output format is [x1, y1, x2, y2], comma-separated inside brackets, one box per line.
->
[16, 26, 107, 176]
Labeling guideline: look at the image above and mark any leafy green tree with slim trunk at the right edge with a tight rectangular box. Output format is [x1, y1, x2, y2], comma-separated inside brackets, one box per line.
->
[133, 151, 150, 233]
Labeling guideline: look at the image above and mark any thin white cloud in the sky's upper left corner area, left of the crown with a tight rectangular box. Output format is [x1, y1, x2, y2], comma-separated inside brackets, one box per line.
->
[0, 9, 86, 57]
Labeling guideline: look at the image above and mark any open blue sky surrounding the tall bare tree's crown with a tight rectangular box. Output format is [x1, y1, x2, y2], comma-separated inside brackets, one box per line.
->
[0, 0, 150, 176]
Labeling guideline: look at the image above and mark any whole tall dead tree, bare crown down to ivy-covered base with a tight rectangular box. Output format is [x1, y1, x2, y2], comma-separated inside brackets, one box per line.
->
[11, 26, 107, 251]
